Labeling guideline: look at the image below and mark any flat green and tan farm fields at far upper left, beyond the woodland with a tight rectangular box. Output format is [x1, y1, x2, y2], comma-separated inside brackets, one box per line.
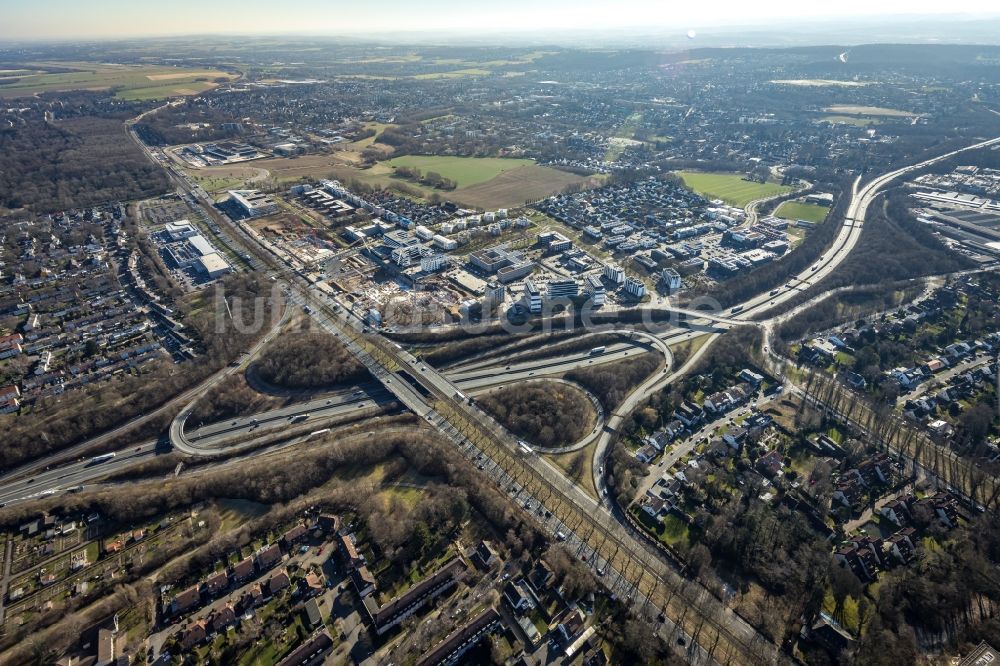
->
[0, 62, 236, 100]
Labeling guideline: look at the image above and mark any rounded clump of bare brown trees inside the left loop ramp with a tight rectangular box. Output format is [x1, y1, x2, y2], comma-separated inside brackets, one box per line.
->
[254, 331, 367, 389]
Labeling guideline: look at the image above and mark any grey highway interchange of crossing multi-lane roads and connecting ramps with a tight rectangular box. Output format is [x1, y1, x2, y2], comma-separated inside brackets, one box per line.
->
[0, 114, 1000, 663]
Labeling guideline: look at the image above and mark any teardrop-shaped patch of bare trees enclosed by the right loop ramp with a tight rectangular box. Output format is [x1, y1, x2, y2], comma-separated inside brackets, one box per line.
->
[479, 382, 594, 448]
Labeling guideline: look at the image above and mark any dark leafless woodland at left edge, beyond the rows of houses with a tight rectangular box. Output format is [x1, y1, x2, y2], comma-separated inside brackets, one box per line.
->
[0, 117, 169, 212]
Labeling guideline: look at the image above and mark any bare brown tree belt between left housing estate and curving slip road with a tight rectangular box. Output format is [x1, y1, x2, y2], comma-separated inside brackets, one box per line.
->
[0, 273, 275, 469]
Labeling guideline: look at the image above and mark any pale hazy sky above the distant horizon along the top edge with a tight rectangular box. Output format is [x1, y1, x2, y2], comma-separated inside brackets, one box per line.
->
[0, 0, 998, 40]
